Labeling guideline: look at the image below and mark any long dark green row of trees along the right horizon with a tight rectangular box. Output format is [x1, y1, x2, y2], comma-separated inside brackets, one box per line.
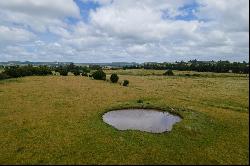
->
[123, 60, 249, 74]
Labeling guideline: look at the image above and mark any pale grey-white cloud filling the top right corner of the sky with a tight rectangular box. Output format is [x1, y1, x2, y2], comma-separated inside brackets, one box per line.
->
[196, 0, 249, 32]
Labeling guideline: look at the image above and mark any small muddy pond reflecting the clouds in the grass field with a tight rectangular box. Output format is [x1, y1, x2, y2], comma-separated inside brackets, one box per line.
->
[103, 109, 181, 133]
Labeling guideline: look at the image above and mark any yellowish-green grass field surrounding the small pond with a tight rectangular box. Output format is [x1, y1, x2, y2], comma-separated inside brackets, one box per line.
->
[0, 70, 249, 164]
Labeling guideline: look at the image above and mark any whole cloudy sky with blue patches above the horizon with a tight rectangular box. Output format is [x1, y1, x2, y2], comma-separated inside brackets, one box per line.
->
[0, 0, 249, 63]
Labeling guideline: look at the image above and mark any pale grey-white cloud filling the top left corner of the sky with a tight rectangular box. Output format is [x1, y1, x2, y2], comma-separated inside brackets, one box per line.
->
[0, 0, 80, 32]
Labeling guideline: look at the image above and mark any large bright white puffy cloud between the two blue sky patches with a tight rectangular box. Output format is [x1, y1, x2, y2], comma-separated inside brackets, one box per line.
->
[91, 0, 199, 40]
